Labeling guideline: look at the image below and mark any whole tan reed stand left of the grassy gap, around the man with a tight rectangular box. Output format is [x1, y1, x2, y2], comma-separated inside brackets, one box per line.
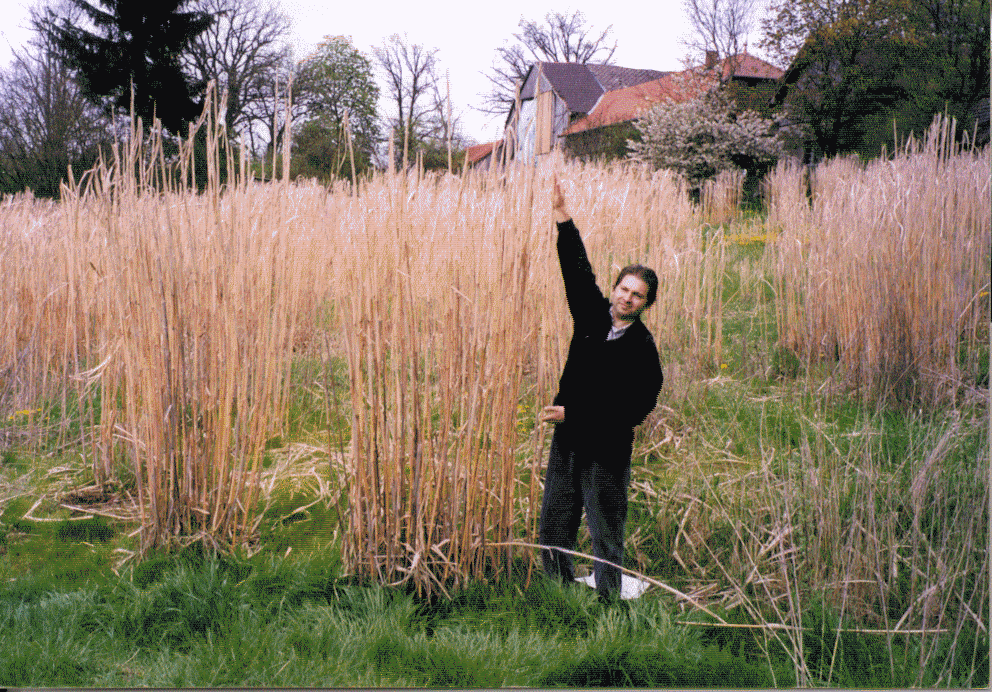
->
[2, 150, 722, 588]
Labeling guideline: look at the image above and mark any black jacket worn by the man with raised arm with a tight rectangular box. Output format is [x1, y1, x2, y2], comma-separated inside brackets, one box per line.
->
[554, 220, 662, 459]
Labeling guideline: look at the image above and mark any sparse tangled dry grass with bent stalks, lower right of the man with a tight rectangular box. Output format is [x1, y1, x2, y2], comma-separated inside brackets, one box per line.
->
[652, 411, 990, 687]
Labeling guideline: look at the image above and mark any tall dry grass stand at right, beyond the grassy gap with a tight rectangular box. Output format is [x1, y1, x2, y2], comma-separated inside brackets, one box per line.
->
[768, 117, 992, 401]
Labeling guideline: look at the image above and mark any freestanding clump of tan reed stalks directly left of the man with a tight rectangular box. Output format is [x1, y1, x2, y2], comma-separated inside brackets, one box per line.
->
[334, 166, 526, 590]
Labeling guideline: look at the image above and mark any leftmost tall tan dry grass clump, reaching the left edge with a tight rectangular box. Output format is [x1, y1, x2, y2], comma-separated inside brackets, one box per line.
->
[0, 108, 305, 549]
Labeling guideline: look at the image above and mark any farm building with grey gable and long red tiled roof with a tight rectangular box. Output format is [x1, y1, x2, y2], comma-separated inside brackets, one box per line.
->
[488, 51, 783, 161]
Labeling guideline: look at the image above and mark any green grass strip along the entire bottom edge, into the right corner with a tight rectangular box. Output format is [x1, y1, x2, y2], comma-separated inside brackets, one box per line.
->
[0, 548, 988, 688]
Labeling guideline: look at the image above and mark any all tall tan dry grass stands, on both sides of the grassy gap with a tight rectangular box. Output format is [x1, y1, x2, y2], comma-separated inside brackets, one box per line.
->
[0, 107, 989, 612]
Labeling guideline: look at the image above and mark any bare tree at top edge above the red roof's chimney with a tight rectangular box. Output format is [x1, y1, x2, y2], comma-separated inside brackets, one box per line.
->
[682, 0, 757, 81]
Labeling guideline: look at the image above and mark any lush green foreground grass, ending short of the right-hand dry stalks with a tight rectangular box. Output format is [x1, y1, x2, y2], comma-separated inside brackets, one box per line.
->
[0, 556, 784, 687]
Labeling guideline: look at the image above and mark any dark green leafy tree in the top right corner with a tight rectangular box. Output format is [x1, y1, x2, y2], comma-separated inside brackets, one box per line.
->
[761, 0, 989, 157]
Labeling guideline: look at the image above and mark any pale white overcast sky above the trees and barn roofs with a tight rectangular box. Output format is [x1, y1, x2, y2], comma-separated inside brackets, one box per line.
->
[0, 0, 772, 142]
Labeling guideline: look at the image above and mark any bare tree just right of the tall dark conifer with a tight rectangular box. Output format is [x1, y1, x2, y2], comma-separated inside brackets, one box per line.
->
[183, 0, 291, 149]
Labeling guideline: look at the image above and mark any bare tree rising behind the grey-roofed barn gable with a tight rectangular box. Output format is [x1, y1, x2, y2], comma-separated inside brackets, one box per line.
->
[479, 10, 617, 115]
